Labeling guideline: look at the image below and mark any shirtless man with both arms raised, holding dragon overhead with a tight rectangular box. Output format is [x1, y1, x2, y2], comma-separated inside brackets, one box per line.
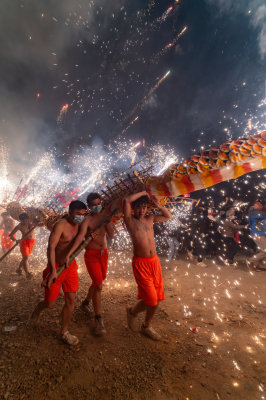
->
[123, 192, 172, 340]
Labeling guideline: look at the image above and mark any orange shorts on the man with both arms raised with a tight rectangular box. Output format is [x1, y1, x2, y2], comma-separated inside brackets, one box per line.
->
[132, 255, 165, 306]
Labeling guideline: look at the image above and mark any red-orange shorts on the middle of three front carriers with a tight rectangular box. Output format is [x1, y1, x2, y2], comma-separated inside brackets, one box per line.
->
[84, 249, 108, 286]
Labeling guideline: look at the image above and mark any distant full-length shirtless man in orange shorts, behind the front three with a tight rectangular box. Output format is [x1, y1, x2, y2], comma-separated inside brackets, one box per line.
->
[9, 213, 35, 279]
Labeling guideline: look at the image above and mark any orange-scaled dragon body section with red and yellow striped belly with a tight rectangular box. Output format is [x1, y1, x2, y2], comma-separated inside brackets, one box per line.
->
[146, 132, 266, 199]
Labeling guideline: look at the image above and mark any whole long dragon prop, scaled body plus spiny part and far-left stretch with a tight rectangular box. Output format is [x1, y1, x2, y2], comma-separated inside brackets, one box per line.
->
[2, 131, 266, 225]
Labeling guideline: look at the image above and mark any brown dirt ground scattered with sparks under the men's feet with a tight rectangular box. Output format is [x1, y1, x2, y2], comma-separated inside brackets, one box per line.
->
[0, 245, 266, 400]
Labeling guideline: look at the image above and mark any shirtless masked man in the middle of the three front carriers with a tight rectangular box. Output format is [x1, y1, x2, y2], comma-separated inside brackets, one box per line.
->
[67, 193, 114, 336]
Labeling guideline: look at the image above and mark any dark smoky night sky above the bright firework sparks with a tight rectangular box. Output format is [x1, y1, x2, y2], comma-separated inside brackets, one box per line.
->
[0, 0, 266, 173]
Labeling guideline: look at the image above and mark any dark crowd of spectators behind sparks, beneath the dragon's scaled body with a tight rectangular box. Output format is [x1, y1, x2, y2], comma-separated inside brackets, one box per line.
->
[155, 197, 266, 270]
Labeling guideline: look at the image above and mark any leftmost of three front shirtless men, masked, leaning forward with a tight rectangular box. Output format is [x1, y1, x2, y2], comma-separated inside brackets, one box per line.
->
[31, 200, 87, 346]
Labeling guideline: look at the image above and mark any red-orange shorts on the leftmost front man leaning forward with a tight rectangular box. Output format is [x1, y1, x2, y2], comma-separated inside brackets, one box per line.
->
[42, 260, 79, 302]
